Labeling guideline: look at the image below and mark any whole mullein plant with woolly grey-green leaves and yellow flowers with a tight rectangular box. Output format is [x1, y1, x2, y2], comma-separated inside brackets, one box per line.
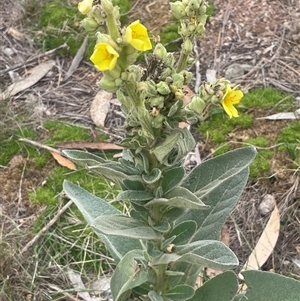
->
[64, 0, 300, 301]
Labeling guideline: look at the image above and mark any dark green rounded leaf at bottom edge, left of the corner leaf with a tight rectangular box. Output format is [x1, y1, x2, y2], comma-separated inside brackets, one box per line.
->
[189, 271, 239, 301]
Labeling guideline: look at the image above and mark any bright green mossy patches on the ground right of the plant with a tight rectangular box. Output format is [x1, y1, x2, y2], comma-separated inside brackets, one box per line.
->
[198, 87, 300, 179]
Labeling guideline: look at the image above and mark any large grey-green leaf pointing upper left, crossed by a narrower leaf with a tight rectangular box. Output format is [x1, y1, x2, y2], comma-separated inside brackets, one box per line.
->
[63, 181, 142, 262]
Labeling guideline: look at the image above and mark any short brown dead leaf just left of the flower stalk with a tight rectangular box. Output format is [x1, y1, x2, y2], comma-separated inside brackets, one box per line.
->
[90, 90, 112, 127]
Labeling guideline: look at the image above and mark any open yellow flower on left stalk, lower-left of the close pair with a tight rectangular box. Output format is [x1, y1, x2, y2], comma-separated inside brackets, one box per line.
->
[90, 43, 119, 71]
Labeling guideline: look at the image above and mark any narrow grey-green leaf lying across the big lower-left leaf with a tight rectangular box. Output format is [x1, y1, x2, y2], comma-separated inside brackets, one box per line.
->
[92, 215, 162, 240]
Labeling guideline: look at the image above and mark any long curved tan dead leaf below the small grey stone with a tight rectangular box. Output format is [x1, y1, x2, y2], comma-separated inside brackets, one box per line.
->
[242, 199, 280, 271]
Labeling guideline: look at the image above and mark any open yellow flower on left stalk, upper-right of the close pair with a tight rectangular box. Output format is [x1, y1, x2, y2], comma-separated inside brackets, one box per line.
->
[125, 20, 152, 51]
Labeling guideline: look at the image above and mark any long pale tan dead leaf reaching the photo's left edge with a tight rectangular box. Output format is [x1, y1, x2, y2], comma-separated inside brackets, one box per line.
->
[0, 60, 55, 99]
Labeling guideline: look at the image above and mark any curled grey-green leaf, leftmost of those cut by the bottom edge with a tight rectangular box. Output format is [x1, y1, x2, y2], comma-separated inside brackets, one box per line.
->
[110, 250, 151, 301]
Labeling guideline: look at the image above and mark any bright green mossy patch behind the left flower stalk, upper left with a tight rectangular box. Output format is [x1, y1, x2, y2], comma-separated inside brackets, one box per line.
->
[24, 0, 131, 59]
